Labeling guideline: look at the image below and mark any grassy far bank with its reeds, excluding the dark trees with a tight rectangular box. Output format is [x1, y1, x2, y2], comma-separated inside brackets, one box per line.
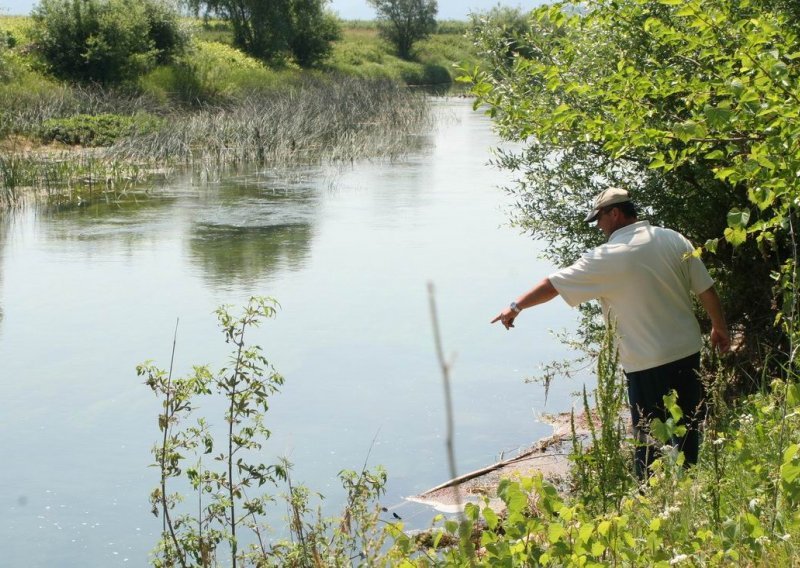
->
[0, 16, 474, 204]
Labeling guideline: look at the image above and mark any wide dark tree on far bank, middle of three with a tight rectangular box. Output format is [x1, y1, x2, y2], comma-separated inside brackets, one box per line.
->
[188, 0, 341, 67]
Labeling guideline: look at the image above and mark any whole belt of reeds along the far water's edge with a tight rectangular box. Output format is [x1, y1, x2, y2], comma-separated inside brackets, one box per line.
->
[0, 76, 431, 207]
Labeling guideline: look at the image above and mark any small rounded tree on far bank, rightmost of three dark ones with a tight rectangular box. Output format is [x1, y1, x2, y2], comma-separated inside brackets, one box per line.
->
[367, 0, 439, 59]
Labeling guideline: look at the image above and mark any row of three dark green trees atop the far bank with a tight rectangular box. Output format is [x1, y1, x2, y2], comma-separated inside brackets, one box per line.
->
[26, 0, 437, 84]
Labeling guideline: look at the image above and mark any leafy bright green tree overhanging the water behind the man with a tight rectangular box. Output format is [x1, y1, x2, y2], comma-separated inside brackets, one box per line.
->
[470, 0, 800, 374]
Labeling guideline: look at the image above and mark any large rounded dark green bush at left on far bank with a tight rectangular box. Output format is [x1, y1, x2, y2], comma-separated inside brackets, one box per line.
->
[32, 0, 187, 84]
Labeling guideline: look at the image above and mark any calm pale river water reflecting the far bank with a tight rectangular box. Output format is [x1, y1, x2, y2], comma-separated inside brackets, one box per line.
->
[0, 99, 580, 567]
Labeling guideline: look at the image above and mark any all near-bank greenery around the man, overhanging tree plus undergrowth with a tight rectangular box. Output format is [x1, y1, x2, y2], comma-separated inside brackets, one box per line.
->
[141, 0, 800, 567]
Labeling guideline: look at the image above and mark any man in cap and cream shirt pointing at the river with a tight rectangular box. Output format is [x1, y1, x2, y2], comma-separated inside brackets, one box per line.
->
[492, 187, 730, 479]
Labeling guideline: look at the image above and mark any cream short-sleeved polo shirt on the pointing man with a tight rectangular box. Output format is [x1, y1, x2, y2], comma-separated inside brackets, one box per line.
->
[549, 221, 714, 372]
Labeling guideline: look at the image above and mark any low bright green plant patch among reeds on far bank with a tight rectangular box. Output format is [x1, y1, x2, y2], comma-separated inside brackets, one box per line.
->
[40, 114, 161, 146]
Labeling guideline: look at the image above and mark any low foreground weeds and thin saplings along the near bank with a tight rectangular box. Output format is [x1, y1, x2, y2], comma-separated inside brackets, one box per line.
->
[144, 298, 800, 568]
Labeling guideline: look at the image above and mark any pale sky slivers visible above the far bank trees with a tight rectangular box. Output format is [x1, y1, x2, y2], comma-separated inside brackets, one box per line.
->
[0, 0, 545, 20]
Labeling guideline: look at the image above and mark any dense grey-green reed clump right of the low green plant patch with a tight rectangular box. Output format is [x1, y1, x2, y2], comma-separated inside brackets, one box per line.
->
[109, 77, 430, 166]
